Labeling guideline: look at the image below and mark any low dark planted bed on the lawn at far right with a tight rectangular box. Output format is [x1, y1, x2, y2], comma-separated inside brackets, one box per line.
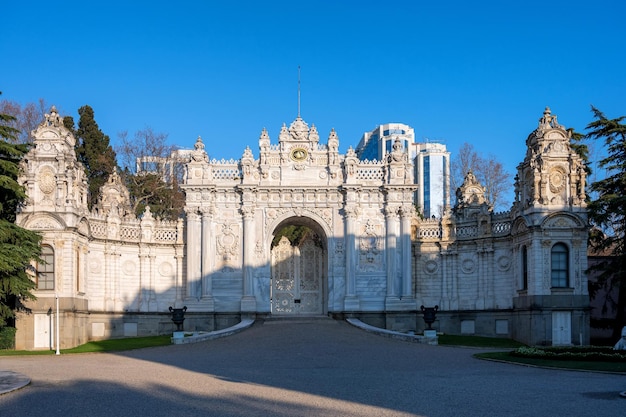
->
[511, 346, 626, 362]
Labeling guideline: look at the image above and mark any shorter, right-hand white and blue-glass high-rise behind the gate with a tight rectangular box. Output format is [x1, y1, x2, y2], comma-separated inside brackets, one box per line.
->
[413, 143, 450, 218]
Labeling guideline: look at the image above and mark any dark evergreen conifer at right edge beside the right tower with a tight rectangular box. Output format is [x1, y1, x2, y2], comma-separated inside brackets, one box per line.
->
[586, 106, 626, 338]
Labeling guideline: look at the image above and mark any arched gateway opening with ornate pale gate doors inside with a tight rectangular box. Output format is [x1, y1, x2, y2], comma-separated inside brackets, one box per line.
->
[270, 218, 328, 316]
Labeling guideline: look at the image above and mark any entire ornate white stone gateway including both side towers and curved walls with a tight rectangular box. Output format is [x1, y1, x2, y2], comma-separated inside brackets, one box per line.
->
[16, 108, 589, 349]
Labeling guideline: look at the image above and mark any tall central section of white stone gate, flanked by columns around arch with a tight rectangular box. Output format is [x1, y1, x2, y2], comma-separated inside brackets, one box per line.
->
[178, 116, 415, 314]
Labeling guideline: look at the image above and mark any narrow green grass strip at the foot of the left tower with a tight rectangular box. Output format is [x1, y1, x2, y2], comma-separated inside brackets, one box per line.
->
[0, 336, 171, 356]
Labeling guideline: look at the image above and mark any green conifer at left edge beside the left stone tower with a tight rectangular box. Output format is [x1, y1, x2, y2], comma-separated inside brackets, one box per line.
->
[0, 93, 41, 328]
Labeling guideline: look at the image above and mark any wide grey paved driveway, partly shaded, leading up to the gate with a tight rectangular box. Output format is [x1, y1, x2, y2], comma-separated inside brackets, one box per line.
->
[0, 319, 626, 417]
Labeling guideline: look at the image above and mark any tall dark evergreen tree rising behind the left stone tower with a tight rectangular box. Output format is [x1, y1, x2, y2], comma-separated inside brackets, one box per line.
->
[73, 106, 117, 209]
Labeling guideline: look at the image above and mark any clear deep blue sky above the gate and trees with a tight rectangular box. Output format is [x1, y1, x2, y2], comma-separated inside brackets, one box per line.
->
[0, 0, 626, 186]
